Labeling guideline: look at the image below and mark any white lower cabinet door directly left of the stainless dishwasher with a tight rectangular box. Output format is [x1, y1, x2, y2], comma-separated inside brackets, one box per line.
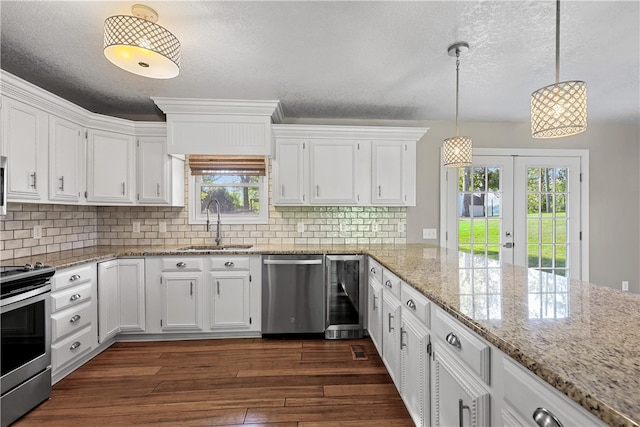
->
[209, 271, 251, 330]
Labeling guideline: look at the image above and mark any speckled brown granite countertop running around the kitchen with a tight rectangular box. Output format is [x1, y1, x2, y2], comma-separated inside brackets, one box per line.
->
[2, 245, 640, 426]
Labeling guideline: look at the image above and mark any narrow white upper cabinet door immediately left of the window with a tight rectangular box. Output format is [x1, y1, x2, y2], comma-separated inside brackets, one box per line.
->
[137, 137, 169, 204]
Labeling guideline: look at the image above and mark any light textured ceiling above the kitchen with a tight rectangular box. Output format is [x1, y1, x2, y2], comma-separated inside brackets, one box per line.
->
[0, 0, 640, 123]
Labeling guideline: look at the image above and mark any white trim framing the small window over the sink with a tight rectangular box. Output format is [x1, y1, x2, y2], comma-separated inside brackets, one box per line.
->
[189, 169, 269, 225]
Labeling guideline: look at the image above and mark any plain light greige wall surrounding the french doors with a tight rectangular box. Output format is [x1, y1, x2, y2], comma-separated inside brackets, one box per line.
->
[407, 121, 640, 293]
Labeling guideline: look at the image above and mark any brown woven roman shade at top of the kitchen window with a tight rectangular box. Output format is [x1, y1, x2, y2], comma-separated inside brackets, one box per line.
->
[189, 154, 267, 176]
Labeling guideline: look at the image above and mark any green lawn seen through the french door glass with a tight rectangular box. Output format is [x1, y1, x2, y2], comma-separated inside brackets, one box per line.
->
[458, 213, 567, 268]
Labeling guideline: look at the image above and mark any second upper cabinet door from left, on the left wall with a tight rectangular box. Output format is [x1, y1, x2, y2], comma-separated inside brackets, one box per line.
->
[49, 115, 85, 203]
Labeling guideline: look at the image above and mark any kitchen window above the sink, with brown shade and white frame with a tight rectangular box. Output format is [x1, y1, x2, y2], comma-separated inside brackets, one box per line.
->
[189, 155, 269, 224]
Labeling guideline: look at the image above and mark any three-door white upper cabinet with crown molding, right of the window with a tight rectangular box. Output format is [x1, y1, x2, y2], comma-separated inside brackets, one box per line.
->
[272, 125, 428, 206]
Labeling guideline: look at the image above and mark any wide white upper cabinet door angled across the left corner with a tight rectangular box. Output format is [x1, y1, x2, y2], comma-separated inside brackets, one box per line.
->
[87, 129, 135, 204]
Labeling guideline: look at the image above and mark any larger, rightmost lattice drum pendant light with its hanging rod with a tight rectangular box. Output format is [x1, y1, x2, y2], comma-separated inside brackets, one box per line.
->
[531, 0, 587, 138]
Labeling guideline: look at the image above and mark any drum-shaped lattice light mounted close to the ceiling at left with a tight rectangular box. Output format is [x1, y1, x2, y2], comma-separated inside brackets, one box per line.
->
[104, 4, 180, 79]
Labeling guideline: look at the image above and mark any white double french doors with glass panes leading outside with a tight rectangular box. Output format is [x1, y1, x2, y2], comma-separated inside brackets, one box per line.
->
[443, 150, 587, 280]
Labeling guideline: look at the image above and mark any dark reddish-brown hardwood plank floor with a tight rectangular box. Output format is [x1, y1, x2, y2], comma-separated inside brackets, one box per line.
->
[15, 338, 413, 427]
